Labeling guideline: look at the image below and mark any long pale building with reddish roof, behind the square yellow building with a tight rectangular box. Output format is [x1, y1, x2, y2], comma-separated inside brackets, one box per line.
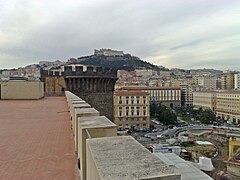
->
[122, 86, 181, 108]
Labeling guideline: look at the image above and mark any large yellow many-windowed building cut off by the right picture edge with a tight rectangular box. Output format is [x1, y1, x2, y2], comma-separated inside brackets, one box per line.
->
[216, 91, 240, 124]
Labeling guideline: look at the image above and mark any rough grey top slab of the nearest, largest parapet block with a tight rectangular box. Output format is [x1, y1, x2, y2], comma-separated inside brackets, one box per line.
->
[87, 136, 181, 180]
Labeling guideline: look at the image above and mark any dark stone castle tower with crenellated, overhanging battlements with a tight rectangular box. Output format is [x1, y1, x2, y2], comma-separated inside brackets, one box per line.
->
[41, 66, 117, 121]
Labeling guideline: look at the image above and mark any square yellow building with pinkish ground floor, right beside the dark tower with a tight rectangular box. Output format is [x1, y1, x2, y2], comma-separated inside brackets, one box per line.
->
[114, 90, 150, 129]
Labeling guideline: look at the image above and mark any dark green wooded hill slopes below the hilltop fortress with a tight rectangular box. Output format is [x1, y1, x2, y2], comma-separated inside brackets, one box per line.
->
[75, 54, 162, 71]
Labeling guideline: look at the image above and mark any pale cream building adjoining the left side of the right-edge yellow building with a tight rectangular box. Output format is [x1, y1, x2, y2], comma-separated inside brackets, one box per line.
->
[193, 91, 216, 112]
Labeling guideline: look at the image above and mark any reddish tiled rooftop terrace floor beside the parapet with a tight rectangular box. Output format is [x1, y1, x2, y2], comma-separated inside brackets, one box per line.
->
[0, 97, 78, 180]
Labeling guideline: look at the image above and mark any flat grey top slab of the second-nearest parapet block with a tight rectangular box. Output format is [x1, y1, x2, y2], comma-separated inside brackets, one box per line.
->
[79, 116, 117, 129]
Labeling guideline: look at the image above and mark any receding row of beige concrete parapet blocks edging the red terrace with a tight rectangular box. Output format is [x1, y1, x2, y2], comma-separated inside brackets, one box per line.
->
[65, 91, 180, 180]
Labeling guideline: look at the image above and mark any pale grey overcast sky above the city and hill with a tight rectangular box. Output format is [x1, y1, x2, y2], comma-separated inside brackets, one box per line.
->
[0, 0, 240, 70]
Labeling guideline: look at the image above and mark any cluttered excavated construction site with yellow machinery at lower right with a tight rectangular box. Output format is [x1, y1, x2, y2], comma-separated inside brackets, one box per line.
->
[135, 127, 240, 180]
